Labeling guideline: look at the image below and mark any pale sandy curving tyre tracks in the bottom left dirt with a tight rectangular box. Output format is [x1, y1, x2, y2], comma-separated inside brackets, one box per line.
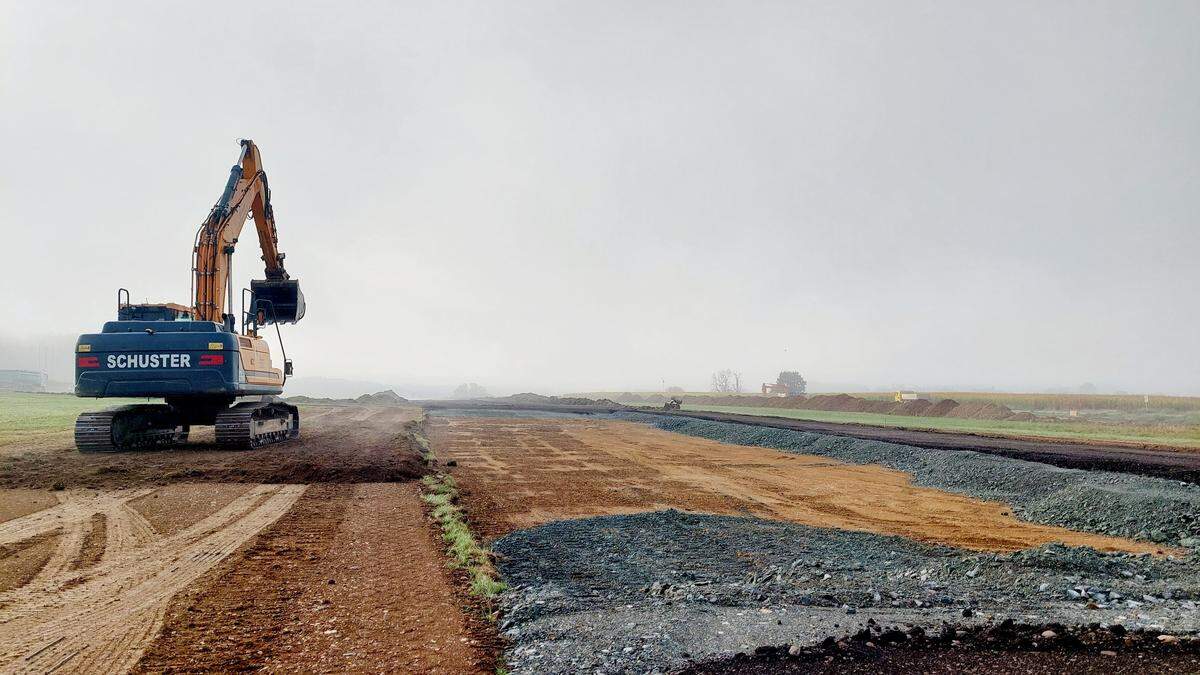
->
[0, 485, 305, 673]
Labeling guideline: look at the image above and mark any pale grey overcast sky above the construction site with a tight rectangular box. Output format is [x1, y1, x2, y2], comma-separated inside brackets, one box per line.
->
[0, 0, 1200, 393]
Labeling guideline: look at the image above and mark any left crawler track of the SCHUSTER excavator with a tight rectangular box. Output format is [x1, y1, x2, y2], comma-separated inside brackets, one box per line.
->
[76, 405, 188, 453]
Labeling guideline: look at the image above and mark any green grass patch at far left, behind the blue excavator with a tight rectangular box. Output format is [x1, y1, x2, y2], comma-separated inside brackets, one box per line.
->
[0, 392, 145, 447]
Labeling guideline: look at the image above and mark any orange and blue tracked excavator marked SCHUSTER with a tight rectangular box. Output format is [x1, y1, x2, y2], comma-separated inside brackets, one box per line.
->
[74, 141, 305, 452]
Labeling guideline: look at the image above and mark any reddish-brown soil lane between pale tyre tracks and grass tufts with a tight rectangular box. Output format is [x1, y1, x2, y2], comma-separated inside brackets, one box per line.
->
[138, 484, 494, 673]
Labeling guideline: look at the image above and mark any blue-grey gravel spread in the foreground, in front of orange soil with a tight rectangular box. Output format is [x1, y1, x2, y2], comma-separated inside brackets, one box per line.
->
[493, 510, 1200, 673]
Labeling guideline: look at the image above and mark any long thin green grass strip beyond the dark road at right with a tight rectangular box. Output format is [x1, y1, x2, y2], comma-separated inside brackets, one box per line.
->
[684, 404, 1200, 448]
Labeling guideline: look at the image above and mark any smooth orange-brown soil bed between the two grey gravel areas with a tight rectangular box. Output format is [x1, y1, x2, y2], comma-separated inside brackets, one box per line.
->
[431, 418, 1160, 552]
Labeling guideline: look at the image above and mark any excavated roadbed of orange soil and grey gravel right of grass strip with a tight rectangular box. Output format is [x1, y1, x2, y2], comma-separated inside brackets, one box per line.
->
[430, 411, 1200, 673]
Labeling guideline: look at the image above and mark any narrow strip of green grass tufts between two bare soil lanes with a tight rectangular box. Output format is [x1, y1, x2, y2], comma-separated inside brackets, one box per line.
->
[421, 473, 508, 599]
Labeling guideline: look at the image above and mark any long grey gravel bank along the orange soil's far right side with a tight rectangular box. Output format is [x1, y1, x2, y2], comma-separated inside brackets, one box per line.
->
[616, 413, 1200, 548]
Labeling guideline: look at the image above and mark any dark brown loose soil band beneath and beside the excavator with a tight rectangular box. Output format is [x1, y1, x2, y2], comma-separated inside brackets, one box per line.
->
[0, 406, 424, 485]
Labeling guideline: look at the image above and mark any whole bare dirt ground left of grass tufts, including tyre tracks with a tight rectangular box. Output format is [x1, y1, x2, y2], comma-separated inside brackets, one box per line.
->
[0, 406, 494, 673]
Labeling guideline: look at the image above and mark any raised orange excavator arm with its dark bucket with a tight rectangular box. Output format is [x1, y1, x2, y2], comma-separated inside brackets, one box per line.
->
[192, 139, 304, 323]
